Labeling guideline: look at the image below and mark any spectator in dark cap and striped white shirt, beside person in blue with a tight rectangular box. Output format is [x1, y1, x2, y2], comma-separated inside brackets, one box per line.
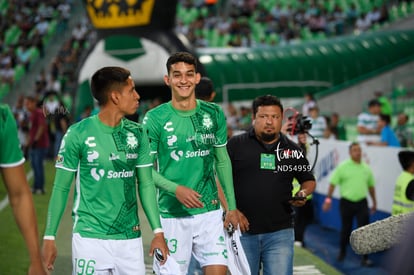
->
[357, 99, 381, 143]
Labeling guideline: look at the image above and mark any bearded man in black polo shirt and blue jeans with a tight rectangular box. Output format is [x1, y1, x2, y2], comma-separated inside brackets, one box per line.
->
[227, 95, 316, 275]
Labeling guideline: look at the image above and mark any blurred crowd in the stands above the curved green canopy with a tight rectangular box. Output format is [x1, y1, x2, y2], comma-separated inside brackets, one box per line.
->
[176, 0, 412, 47]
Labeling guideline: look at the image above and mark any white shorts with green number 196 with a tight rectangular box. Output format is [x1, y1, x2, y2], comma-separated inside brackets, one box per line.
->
[72, 233, 145, 275]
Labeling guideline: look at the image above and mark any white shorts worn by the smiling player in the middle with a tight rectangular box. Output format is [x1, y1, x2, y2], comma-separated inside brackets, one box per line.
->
[161, 209, 227, 274]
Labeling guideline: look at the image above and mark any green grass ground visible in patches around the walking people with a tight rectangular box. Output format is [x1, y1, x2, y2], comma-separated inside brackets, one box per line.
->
[0, 161, 341, 275]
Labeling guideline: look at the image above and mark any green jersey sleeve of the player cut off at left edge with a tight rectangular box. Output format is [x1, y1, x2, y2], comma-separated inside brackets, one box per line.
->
[0, 105, 24, 167]
